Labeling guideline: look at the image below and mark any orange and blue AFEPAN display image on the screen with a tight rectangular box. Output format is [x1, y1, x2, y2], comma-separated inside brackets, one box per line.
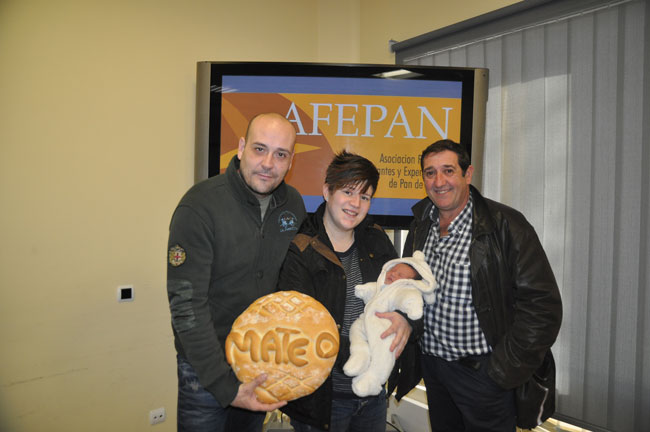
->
[221, 76, 462, 215]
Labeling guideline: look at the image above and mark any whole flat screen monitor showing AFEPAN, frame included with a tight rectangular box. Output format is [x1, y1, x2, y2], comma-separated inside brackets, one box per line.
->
[196, 62, 487, 229]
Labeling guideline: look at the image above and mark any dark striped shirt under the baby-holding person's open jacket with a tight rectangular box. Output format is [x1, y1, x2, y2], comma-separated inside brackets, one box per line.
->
[332, 243, 364, 394]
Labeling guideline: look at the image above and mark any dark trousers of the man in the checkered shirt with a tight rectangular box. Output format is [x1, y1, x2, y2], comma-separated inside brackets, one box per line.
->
[421, 354, 516, 432]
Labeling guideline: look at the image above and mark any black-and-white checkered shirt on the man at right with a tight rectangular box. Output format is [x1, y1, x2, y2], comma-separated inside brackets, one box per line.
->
[420, 195, 491, 360]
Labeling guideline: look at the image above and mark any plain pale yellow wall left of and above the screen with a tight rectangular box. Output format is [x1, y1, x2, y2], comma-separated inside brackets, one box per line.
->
[0, 0, 514, 431]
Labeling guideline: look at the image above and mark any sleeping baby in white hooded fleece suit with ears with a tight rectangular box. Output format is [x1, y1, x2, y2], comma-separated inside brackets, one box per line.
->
[343, 251, 437, 397]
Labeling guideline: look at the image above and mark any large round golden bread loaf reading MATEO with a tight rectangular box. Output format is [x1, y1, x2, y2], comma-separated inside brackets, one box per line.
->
[226, 291, 339, 403]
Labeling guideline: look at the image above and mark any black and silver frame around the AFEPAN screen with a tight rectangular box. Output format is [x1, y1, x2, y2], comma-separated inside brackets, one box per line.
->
[195, 62, 487, 229]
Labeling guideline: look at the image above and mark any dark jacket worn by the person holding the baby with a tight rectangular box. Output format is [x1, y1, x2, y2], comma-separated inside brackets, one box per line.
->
[278, 204, 423, 430]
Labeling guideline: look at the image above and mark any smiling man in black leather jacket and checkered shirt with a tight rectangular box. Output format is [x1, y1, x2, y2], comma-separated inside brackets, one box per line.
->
[404, 140, 562, 432]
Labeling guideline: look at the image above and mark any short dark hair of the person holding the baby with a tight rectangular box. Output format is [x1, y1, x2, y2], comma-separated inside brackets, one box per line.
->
[325, 150, 379, 195]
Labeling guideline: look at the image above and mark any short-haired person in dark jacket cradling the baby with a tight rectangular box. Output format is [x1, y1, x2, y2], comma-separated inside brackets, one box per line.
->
[278, 151, 421, 432]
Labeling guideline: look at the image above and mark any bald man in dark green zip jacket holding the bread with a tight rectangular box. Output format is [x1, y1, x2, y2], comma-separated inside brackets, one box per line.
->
[167, 113, 306, 432]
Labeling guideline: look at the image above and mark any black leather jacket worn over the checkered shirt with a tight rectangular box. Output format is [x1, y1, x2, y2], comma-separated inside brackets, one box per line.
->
[404, 186, 562, 418]
